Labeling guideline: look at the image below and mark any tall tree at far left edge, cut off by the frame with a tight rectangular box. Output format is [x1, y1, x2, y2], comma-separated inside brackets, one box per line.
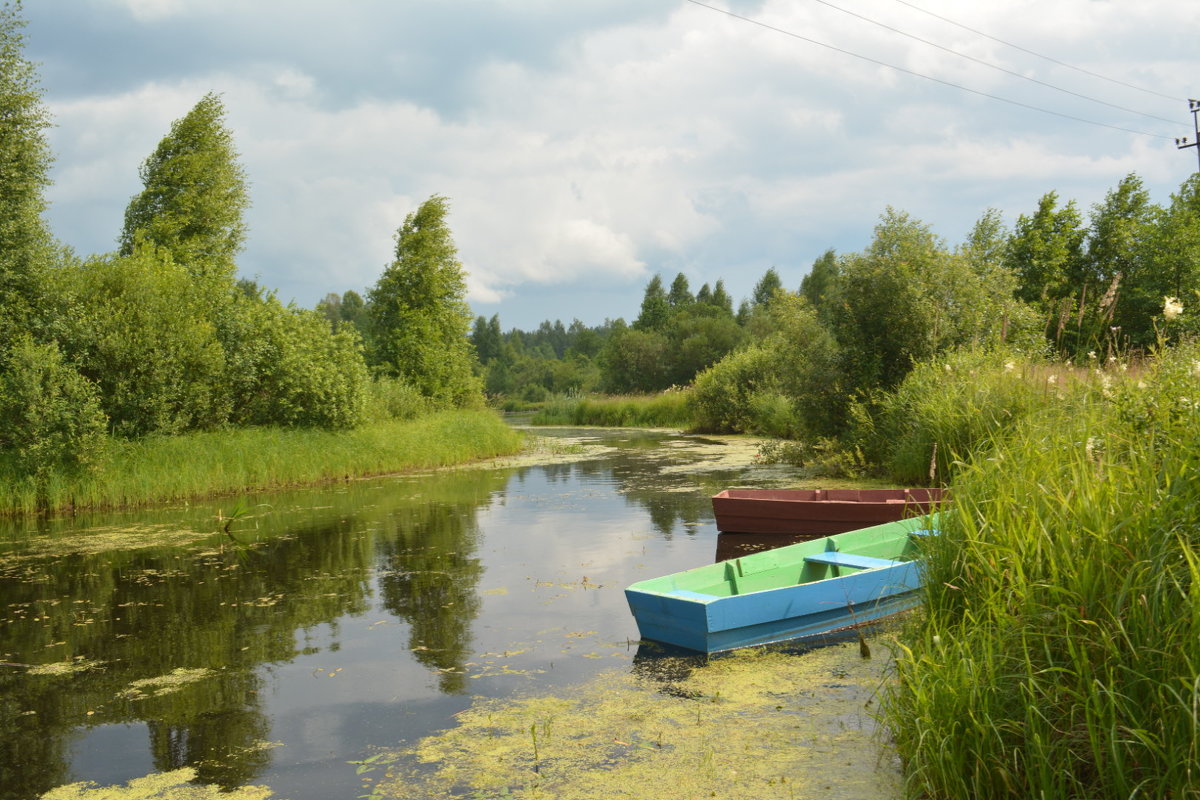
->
[0, 5, 54, 347]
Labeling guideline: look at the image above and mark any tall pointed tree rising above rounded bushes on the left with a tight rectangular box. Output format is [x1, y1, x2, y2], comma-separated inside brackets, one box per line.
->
[120, 94, 248, 286]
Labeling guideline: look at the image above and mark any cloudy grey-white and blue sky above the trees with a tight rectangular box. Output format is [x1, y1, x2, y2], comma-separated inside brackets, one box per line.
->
[24, 0, 1200, 329]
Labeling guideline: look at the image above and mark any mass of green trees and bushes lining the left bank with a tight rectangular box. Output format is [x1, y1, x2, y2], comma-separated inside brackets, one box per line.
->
[0, 5, 482, 494]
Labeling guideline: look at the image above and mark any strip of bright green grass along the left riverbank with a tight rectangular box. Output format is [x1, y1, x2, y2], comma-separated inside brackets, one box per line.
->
[0, 411, 521, 513]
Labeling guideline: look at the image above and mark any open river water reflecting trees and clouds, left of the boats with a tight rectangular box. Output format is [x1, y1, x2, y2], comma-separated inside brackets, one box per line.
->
[0, 428, 902, 800]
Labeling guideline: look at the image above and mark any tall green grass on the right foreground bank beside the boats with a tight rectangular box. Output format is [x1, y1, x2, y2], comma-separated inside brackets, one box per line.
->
[886, 349, 1200, 799]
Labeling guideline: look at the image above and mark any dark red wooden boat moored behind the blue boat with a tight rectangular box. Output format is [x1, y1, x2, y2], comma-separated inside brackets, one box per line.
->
[713, 488, 946, 561]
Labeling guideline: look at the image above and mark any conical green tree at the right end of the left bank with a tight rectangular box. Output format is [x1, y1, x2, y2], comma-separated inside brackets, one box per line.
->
[368, 196, 481, 405]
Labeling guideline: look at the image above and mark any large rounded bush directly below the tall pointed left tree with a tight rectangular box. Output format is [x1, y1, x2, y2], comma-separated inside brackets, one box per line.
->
[55, 246, 230, 435]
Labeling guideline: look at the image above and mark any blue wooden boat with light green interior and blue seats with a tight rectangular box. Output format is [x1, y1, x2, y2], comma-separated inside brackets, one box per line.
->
[625, 516, 936, 652]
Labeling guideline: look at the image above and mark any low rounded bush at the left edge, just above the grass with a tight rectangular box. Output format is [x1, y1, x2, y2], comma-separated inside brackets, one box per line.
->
[0, 335, 107, 495]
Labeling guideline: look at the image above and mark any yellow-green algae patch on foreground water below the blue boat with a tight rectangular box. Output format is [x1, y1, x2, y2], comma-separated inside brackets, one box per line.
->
[368, 645, 900, 800]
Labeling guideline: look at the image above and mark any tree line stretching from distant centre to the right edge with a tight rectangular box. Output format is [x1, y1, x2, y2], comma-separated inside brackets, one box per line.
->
[448, 169, 1200, 443]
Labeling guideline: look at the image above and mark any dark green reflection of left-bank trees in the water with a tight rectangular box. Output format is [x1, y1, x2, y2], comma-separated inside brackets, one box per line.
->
[0, 471, 504, 799]
